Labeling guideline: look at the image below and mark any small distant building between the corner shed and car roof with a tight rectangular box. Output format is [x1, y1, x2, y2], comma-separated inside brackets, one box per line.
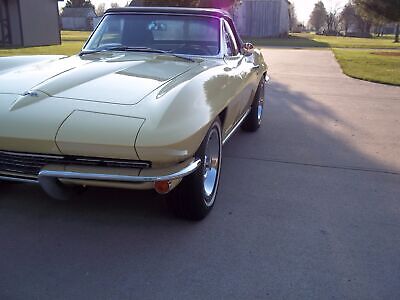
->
[61, 7, 97, 30]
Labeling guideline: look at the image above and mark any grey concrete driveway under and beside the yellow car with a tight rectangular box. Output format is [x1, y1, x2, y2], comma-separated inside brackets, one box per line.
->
[0, 49, 400, 299]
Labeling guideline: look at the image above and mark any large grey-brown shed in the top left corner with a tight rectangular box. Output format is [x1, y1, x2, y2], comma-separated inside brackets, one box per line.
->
[0, 0, 61, 47]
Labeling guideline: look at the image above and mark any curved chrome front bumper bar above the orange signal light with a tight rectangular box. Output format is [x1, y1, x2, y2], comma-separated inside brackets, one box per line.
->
[39, 159, 201, 183]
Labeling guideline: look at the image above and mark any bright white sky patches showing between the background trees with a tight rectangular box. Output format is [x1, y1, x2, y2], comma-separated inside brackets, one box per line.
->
[60, 0, 348, 23]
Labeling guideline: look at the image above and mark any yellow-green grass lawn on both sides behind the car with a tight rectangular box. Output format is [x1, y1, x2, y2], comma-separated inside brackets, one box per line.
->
[0, 31, 400, 85]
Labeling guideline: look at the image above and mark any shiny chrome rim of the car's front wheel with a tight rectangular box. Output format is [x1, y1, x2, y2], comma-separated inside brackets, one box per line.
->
[203, 128, 221, 206]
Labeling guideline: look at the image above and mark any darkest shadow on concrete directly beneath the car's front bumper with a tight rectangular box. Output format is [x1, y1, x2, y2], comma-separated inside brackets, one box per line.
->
[2, 180, 173, 223]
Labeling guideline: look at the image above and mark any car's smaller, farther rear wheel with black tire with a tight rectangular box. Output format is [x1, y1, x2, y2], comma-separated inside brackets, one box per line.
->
[242, 77, 265, 132]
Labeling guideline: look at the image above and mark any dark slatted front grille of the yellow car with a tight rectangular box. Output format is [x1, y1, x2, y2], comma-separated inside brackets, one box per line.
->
[0, 151, 151, 178]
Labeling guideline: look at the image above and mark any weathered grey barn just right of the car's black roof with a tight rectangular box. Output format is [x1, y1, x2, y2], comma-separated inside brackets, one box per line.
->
[232, 0, 289, 37]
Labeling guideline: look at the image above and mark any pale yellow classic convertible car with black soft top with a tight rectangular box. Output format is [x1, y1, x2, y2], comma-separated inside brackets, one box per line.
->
[0, 8, 268, 220]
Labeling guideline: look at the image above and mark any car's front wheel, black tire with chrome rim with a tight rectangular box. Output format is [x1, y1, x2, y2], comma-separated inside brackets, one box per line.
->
[167, 118, 222, 221]
